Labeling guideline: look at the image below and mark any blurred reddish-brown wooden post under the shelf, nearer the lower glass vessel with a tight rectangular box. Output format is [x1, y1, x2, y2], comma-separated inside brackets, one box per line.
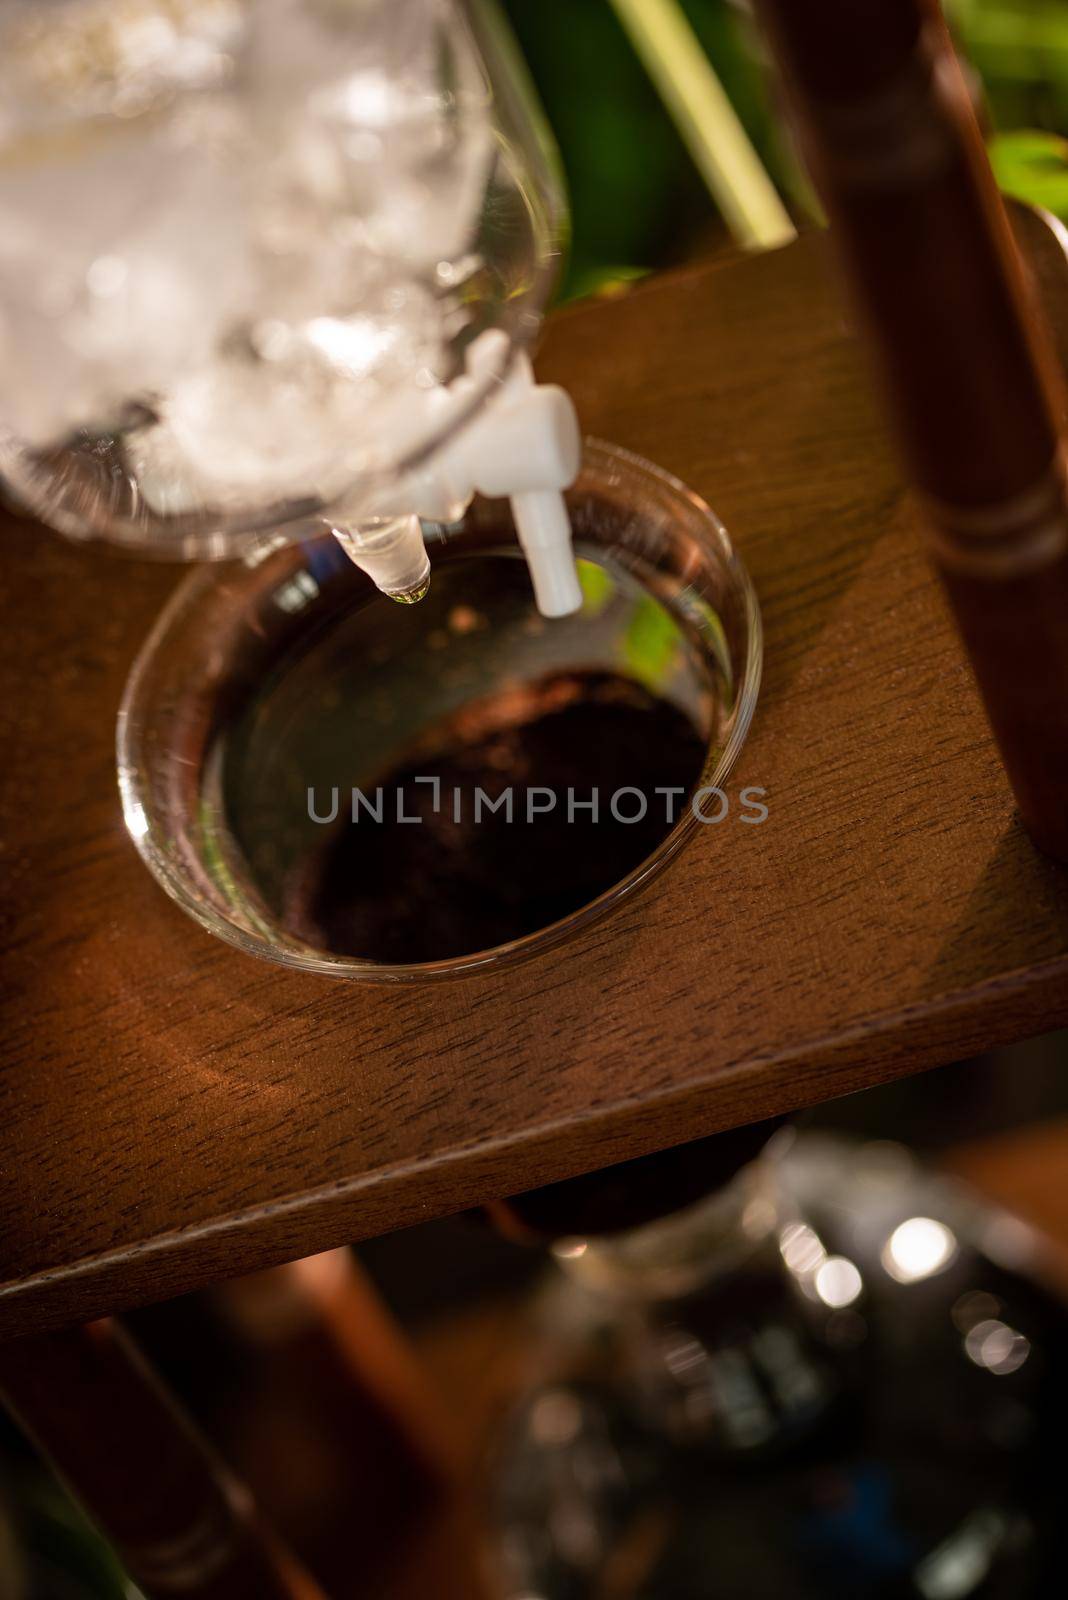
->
[214, 1250, 488, 1600]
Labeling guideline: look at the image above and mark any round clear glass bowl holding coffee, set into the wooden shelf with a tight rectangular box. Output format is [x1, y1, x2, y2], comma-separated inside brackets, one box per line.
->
[118, 440, 761, 982]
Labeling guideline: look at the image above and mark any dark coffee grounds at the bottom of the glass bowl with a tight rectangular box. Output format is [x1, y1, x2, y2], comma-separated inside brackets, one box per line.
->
[285, 672, 707, 963]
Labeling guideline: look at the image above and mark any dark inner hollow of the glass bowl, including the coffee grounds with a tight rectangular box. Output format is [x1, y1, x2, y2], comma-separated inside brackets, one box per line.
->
[217, 544, 729, 965]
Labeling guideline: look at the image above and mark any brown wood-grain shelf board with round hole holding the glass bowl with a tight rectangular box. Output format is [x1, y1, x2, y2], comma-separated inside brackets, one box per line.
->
[0, 238, 1068, 1336]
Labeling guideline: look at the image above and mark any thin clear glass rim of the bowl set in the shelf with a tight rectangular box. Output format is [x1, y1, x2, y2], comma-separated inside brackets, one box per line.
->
[115, 437, 764, 986]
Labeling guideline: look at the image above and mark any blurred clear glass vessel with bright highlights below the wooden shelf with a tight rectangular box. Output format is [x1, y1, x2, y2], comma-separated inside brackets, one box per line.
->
[491, 1134, 1068, 1600]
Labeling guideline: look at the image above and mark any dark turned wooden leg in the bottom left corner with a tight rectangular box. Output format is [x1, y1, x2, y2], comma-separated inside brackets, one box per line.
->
[0, 1320, 323, 1600]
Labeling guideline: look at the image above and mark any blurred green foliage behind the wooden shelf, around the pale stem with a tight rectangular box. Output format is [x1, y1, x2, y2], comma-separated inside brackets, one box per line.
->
[504, 0, 1068, 299]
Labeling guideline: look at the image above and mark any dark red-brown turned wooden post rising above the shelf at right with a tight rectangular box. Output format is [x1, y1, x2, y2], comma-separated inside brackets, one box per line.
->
[758, 0, 1068, 861]
